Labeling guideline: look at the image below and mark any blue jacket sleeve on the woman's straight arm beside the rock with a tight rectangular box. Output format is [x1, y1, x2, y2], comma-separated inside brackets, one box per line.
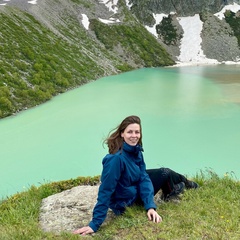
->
[89, 155, 122, 232]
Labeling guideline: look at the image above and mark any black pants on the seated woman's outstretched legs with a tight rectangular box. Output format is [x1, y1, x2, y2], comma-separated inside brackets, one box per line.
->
[147, 168, 188, 195]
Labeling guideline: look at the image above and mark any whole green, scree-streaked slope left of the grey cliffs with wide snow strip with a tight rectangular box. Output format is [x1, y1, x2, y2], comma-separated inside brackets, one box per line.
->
[0, 0, 174, 118]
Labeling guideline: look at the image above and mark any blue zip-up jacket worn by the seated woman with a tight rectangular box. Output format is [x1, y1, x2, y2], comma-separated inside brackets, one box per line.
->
[89, 143, 156, 232]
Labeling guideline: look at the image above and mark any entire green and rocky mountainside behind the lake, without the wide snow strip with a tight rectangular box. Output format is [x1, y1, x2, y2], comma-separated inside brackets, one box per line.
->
[0, 0, 240, 118]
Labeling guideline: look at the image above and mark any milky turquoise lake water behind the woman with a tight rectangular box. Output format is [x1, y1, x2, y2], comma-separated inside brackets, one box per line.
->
[0, 65, 240, 197]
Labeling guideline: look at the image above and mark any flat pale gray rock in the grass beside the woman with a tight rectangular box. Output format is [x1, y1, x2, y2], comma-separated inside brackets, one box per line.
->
[39, 186, 114, 233]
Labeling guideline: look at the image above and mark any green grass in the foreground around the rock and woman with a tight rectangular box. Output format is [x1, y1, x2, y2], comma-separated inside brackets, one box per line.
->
[0, 172, 240, 240]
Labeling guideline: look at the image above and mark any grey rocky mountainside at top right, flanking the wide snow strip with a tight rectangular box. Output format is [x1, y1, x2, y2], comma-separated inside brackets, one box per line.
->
[130, 0, 240, 62]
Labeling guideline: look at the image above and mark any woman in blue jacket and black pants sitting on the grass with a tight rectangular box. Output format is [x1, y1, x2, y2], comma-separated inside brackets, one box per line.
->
[74, 116, 198, 235]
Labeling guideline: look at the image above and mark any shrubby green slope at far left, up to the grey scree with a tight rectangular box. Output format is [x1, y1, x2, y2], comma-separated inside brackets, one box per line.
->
[0, 8, 103, 117]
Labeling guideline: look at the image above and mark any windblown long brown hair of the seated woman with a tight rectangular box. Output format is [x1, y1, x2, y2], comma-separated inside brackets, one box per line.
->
[104, 115, 142, 154]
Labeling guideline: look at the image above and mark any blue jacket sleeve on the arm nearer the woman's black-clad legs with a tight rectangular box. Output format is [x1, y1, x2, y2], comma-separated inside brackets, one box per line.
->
[139, 156, 157, 210]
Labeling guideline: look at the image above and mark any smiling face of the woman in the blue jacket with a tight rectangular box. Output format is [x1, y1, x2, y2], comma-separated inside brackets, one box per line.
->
[121, 123, 141, 146]
